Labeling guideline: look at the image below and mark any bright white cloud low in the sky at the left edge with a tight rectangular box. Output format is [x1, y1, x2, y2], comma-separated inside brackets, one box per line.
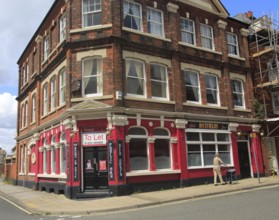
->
[0, 92, 17, 153]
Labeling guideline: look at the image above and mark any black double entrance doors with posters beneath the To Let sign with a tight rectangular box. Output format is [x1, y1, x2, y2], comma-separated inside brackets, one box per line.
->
[83, 147, 108, 191]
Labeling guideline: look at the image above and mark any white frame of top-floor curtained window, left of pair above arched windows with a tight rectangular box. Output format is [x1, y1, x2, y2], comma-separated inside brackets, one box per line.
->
[123, 0, 142, 32]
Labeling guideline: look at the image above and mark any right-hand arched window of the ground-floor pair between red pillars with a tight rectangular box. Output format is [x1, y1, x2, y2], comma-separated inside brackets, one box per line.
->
[153, 128, 171, 169]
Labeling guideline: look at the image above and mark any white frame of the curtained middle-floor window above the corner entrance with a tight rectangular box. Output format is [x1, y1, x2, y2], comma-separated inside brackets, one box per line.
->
[82, 56, 103, 97]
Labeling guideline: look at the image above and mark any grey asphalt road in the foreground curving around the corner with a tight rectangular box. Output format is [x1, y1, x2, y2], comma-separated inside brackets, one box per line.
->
[0, 187, 279, 220]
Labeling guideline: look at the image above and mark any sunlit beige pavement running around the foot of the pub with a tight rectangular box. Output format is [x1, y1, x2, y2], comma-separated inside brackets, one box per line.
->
[0, 176, 279, 215]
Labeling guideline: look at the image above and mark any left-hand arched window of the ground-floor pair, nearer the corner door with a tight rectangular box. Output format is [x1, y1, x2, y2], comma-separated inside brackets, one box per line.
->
[128, 127, 148, 171]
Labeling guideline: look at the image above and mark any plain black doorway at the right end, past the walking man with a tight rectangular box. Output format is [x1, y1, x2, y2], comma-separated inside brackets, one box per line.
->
[238, 142, 251, 178]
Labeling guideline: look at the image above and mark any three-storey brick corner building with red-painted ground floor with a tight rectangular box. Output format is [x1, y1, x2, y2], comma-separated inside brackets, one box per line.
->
[17, 0, 264, 198]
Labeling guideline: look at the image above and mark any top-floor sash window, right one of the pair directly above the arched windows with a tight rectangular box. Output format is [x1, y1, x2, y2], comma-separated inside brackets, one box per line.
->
[147, 7, 165, 37]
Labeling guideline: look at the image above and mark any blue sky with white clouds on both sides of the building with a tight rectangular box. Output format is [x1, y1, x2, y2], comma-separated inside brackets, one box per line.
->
[0, 0, 279, 154]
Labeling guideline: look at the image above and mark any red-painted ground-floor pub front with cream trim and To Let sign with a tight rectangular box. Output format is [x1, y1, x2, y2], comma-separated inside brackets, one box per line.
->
[17, 113, 264, 198]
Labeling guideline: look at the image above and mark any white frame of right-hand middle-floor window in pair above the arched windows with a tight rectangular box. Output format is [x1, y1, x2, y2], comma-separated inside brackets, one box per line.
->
[150, 63, 169, 100]
